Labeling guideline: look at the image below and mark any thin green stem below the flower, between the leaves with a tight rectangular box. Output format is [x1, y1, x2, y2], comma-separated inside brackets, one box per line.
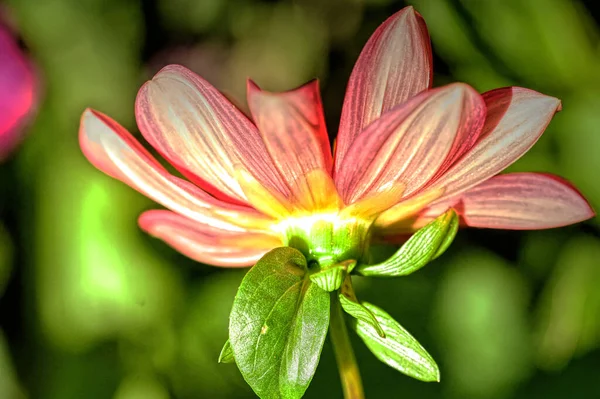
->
[329, 291, 365, 399]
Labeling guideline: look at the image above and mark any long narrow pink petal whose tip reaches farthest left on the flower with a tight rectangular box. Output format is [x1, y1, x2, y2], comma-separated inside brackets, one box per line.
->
[79, 109, 271, 232]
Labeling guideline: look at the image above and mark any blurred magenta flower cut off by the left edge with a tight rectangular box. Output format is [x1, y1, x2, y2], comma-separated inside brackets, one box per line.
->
[0, 25, 36, 161]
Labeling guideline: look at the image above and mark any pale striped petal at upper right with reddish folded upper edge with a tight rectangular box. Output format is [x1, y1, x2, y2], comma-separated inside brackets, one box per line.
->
[433, 87, 560, 198]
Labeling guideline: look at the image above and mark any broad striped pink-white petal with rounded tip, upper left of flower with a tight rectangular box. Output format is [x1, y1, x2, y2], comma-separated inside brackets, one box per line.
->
[136, 65, 288, 204]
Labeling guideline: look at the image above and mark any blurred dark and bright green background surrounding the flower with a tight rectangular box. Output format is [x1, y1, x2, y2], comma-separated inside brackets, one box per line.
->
[0, 0, 600, 399]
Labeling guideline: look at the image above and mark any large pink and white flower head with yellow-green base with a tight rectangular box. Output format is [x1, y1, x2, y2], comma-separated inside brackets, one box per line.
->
[80, 7, 594, 267]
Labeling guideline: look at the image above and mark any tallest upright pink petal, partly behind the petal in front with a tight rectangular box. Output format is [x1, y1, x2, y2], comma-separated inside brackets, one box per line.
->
[335, 7, 433, 172]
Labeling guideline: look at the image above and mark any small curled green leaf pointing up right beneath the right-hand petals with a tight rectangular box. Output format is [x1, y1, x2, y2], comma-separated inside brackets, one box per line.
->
[356, 209, 459, 277]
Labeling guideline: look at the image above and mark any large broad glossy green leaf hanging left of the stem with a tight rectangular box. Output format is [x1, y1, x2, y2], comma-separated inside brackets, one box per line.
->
[229, 247, 329, 399]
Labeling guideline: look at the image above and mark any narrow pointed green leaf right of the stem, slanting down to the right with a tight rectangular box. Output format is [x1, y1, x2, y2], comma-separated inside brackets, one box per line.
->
[352, 302, 440, 382]
